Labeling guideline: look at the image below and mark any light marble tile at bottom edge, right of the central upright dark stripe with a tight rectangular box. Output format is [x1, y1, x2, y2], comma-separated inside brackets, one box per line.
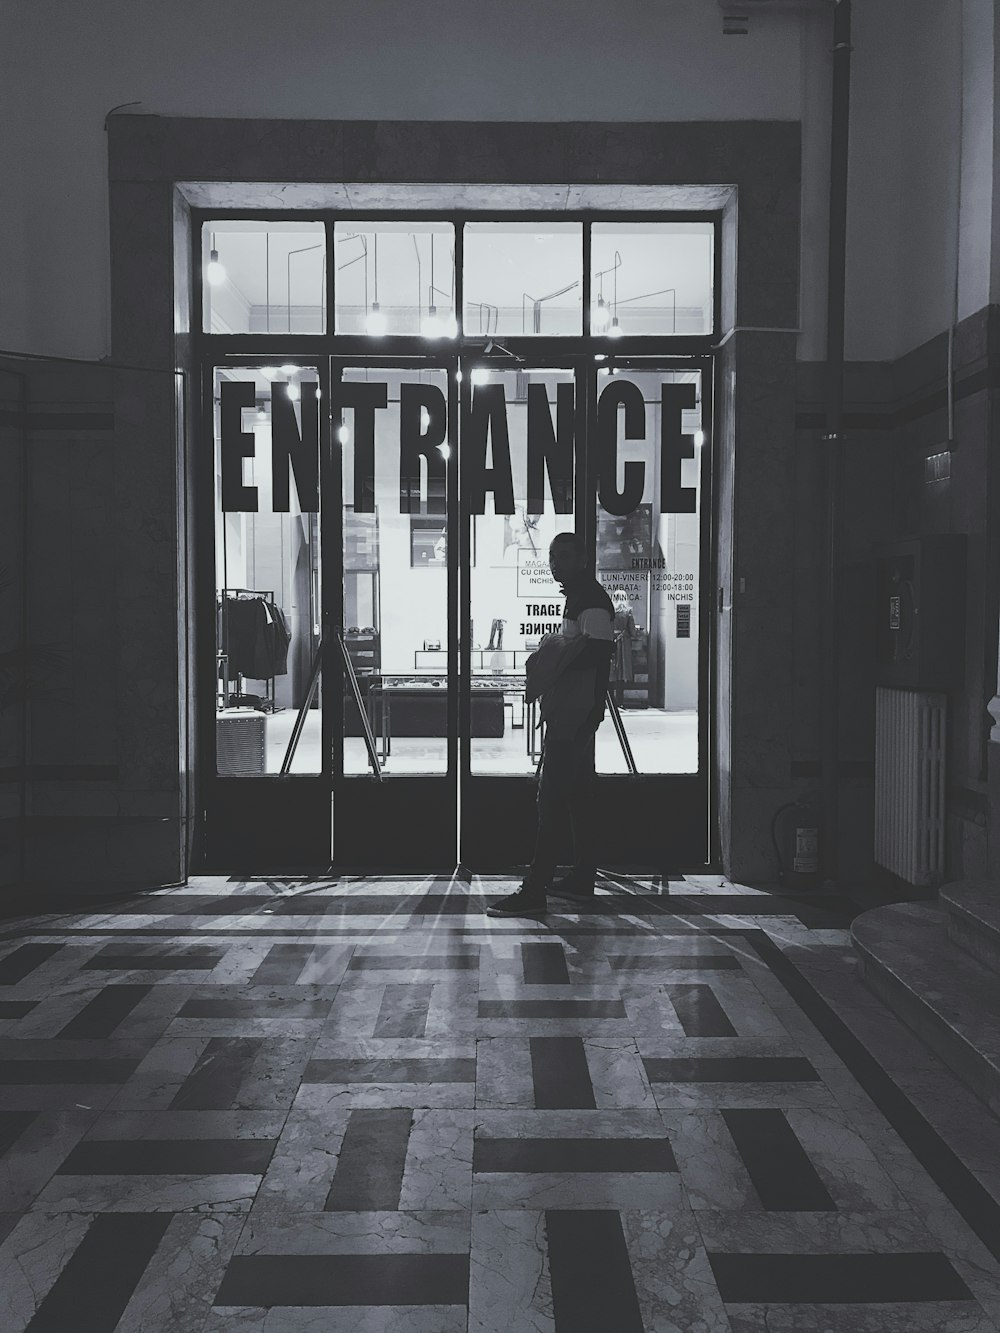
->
[621, 1208, 729, 1333]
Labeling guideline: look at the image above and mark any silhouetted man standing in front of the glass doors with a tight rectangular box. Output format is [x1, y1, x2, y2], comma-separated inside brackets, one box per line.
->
[487, 532, 615, 916]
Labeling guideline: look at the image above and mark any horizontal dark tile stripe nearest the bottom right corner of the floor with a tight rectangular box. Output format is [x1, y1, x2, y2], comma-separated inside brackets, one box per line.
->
[708, 1253, 972, 1305]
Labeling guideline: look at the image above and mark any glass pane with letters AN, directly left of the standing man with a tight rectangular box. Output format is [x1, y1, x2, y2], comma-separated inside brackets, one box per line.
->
[472, 368, 575, 774]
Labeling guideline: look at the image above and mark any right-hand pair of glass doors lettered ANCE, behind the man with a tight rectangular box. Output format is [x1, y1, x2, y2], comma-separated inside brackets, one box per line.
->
[460, 360, 711, 872]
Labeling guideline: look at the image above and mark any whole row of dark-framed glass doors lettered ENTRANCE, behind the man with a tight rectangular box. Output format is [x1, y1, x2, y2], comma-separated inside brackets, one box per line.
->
[204, 355, 711, 870]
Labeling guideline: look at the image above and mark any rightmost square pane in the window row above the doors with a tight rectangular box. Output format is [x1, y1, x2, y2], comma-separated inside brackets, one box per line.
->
[591, 223, 715, 337]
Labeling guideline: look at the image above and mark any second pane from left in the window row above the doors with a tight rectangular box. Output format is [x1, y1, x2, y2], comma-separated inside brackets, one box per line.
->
[333, 221, 457, 337]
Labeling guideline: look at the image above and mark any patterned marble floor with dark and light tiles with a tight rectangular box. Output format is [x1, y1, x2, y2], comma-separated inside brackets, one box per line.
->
[0, 876, 1000, 1333]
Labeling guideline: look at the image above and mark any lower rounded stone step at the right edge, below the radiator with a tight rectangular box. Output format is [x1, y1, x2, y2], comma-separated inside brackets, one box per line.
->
[851, 902, 1000, 1114]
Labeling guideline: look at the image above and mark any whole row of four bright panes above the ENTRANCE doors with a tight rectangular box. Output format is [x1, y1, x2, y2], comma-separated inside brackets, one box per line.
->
[201, 215, 717, 345]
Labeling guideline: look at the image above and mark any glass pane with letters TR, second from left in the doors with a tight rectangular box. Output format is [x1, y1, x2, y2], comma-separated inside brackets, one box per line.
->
[337, 368, 448, 777]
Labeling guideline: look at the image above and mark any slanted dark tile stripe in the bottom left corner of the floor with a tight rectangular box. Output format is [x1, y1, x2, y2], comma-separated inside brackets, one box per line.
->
[25, 1213, 173, 1333]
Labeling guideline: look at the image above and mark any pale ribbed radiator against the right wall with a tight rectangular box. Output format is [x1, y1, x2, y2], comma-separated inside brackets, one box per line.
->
[875, 685, 947, 885]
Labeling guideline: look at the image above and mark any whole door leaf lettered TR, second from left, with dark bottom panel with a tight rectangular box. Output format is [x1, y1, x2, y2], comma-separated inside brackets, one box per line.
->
[324, 357, 459, 870]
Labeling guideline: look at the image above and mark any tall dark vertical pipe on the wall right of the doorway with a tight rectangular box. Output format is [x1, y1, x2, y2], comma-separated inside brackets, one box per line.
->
[820, 0, 851, 882]
